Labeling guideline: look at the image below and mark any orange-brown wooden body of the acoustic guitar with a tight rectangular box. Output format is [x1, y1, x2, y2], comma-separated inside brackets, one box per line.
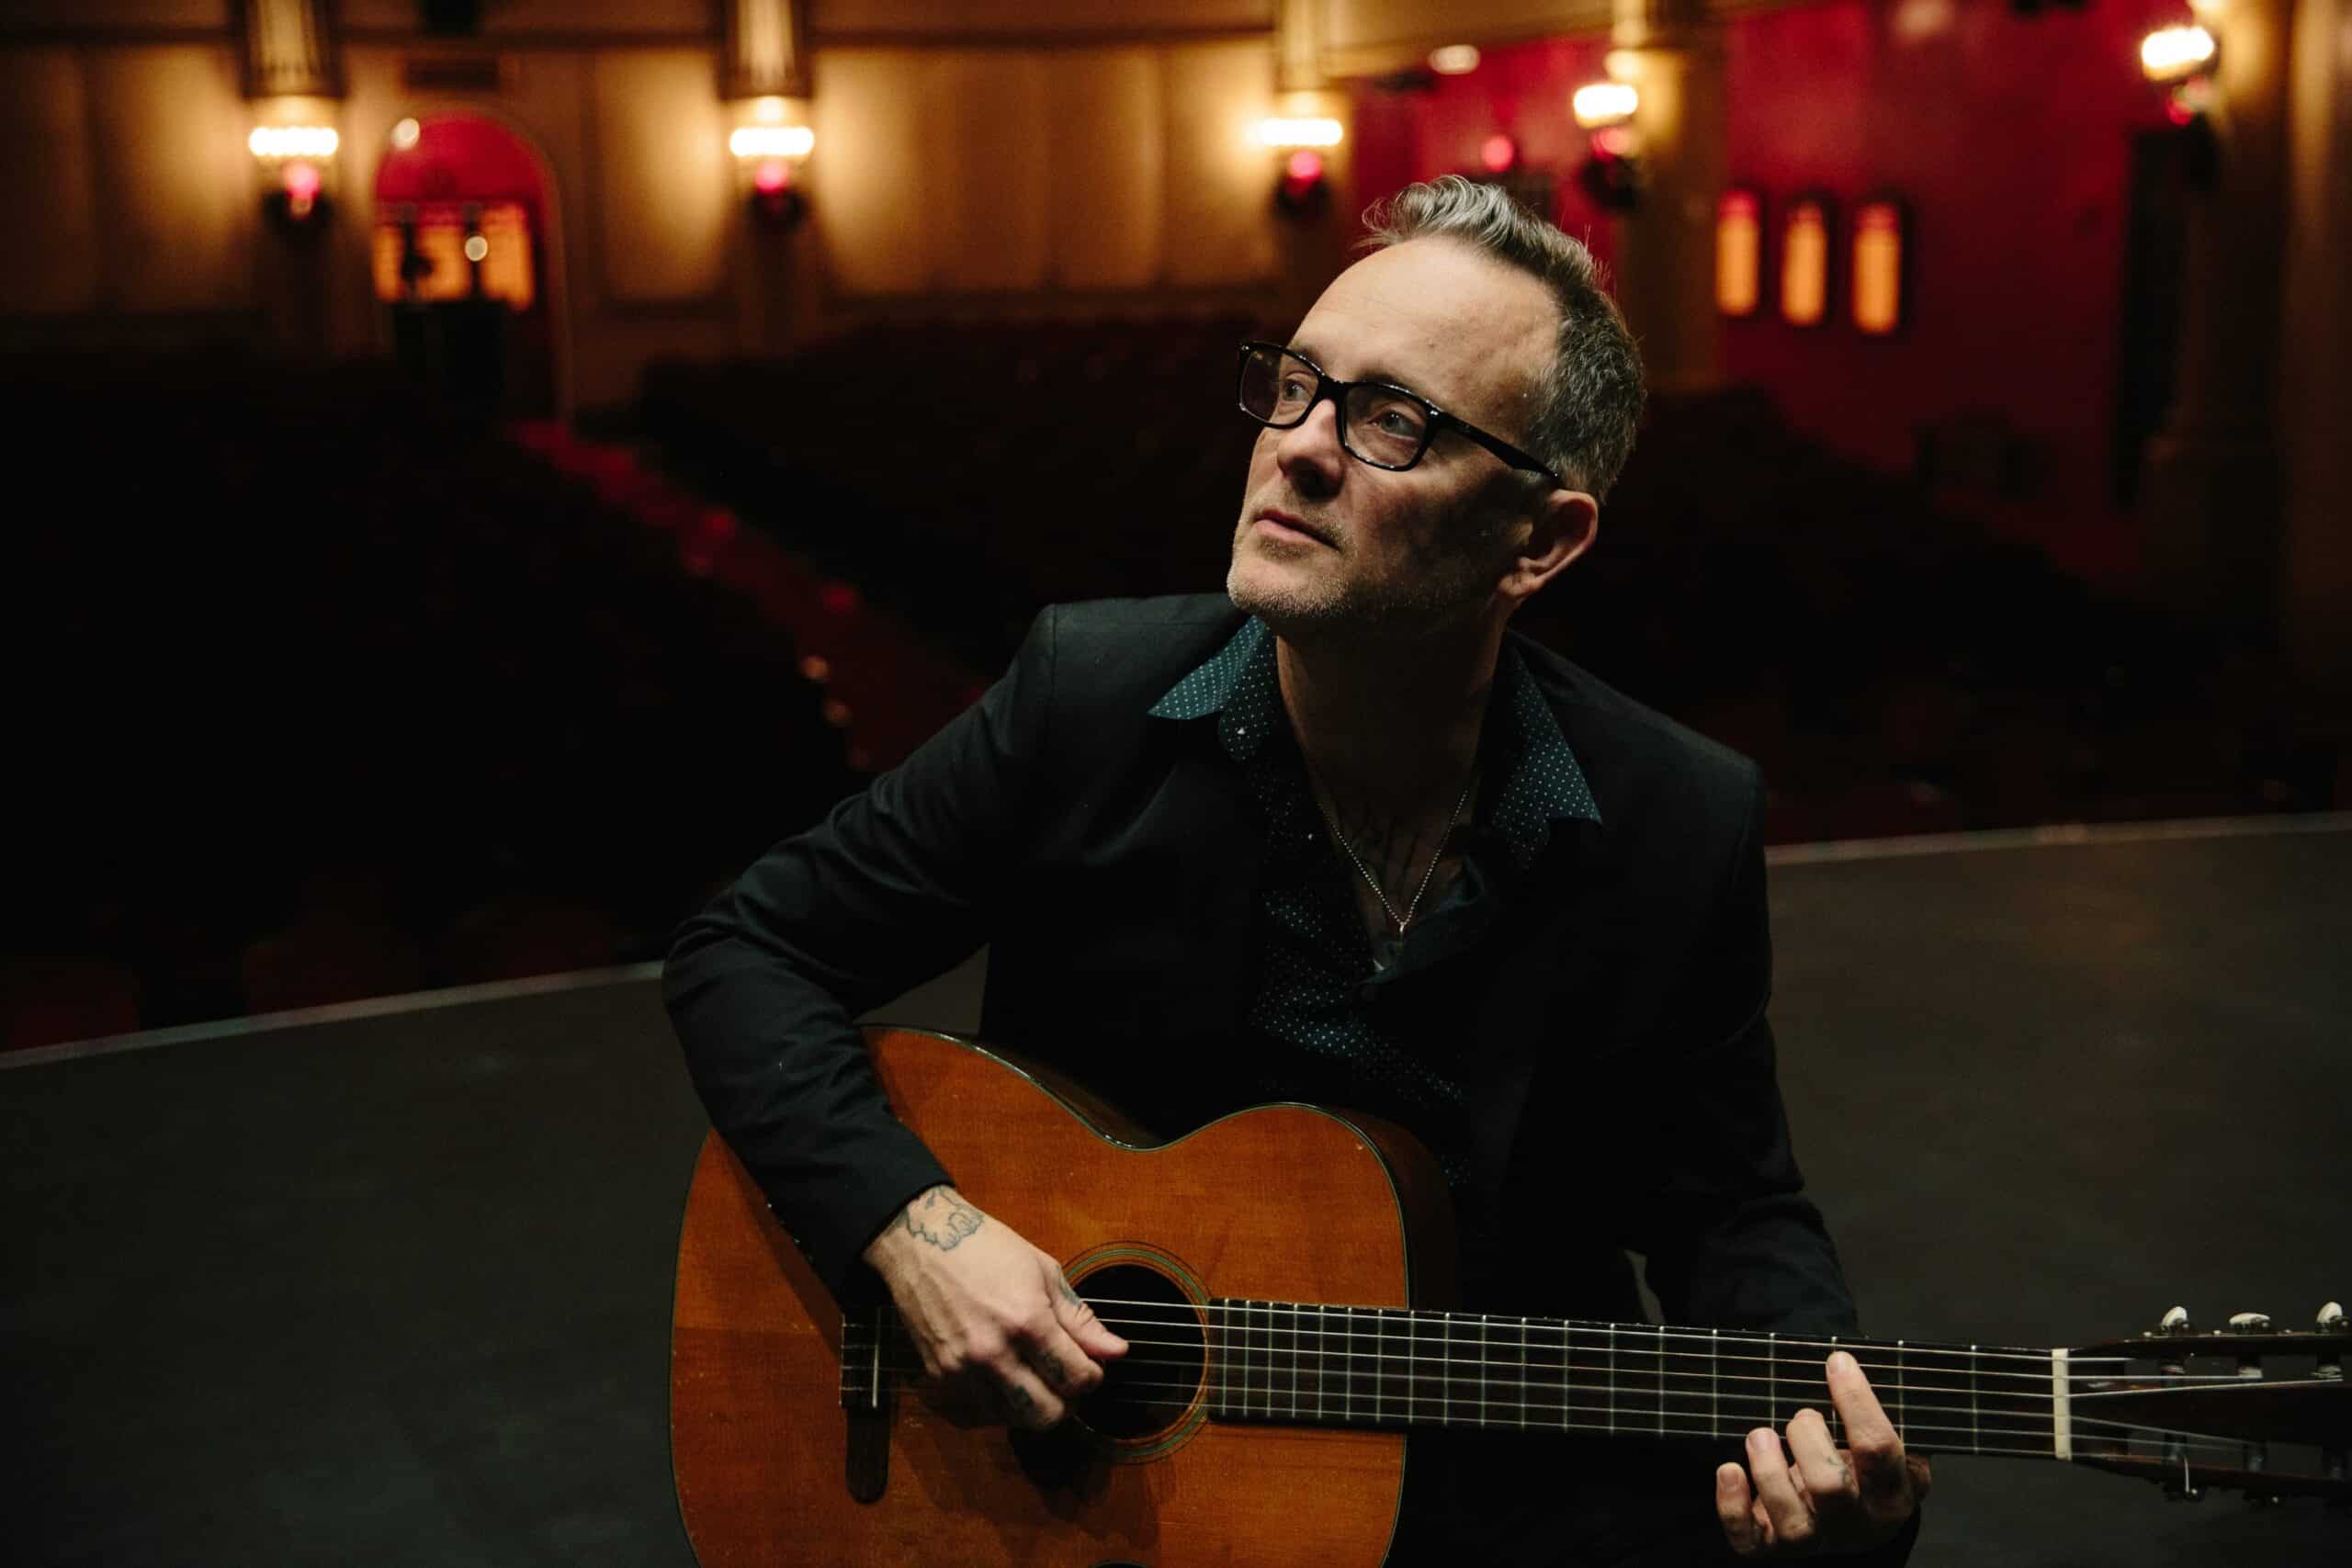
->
[671, 1032, 1452, 1568]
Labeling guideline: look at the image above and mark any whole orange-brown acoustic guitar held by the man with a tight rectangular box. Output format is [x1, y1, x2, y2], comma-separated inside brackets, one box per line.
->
[671, 1032, 2352, 1568]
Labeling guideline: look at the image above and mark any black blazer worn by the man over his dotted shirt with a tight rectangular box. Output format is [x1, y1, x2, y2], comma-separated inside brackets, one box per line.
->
[663, 594, 1856, 1333]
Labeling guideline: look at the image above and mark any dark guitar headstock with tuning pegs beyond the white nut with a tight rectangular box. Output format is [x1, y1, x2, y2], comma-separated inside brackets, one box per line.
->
[2067, 1303, 2352, 1509]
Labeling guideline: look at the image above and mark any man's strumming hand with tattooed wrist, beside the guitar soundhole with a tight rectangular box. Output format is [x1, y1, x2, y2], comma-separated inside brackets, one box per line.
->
[865, 1187, 1126, 1432]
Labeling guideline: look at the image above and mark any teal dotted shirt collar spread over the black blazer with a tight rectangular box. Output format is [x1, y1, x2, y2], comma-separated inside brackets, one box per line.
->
[1150, 616, 1601, 870]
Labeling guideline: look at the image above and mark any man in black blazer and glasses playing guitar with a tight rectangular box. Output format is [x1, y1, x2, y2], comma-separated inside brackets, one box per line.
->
[665, 179, 1927, 1563]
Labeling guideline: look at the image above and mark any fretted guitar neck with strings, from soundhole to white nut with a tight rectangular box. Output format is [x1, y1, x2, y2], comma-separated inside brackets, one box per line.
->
[1206, 1300, 2079, 1460]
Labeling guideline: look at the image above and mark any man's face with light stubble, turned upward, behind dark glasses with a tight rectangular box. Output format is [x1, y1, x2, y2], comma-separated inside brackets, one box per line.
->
[1226, 237, 1559, 635]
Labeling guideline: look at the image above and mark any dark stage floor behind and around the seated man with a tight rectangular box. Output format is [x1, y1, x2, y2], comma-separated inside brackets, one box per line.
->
[0, 818, 2352, 1568]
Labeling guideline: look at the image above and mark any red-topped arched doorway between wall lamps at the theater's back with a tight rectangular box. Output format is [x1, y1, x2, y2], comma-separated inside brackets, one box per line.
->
[371, 110, 564, 419]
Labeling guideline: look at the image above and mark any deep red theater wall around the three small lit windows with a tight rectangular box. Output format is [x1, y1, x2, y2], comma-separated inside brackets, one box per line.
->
[1357, 0, 2173, 579]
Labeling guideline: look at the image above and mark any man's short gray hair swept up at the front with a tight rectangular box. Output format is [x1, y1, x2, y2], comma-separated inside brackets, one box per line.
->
[1364, 174, 1642, 499]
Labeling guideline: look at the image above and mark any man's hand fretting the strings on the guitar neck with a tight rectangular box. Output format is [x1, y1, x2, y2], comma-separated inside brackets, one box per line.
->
[1714, 1352, 1933, 1556]
